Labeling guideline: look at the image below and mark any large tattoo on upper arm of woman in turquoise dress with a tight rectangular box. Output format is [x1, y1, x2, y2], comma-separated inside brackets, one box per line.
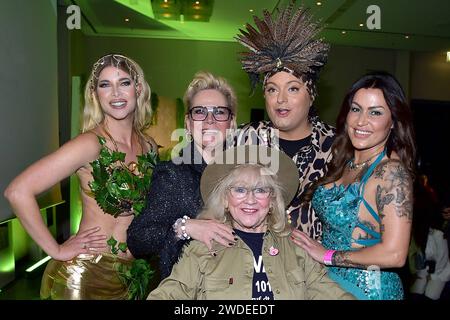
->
[374, 161, 412, 220]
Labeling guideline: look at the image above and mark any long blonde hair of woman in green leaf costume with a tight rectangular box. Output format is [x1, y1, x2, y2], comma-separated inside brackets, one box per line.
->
[82, 54, 152, 135]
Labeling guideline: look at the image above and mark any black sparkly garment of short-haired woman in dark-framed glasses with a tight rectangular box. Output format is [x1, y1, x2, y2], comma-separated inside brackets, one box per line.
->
[127, 143, 206, 279]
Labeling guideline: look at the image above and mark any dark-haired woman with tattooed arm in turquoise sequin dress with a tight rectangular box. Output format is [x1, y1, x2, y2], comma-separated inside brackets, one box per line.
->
[291, 72, 415, 300]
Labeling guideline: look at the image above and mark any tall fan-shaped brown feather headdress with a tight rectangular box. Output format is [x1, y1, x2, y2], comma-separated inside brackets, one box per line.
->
[236, 1, 330, 98]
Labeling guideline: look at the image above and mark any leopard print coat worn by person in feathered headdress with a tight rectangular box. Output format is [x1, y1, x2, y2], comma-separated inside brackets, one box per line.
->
[234, 116, 335, 240]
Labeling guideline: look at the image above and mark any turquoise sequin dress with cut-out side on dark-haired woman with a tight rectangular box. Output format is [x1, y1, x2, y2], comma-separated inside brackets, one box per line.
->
[312, 152, 403, 300]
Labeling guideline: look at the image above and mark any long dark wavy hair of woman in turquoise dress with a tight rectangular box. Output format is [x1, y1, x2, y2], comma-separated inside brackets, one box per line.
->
[303, 72, 416, 201]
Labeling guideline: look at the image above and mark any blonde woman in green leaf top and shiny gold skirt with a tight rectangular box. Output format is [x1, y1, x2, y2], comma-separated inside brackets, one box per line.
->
[5, 54, 157, 299]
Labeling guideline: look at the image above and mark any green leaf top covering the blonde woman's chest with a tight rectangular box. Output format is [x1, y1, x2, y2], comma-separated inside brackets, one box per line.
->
[88, 135, 159, 217]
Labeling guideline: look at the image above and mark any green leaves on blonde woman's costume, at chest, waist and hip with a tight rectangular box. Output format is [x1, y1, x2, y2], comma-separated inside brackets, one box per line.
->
[89, 136, 159, 300]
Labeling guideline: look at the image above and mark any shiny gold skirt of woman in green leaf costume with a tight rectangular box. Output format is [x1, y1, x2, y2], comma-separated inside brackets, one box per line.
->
[40, 253, 133, 300]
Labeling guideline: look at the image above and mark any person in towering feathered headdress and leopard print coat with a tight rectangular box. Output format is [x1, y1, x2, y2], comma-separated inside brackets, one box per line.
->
[235, 1, 335, 239]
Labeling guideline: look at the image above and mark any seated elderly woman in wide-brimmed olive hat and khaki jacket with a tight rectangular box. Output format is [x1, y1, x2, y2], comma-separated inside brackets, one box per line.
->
[148, 145, 353, 300]
